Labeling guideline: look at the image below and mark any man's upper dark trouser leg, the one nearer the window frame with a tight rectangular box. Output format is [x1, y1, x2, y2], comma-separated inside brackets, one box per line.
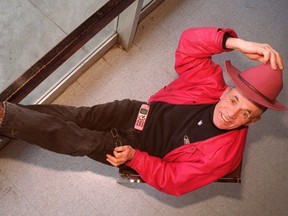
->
[18, 99, 143, 131]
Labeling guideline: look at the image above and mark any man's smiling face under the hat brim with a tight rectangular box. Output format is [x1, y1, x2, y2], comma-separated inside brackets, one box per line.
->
[213, 88, 263, 130]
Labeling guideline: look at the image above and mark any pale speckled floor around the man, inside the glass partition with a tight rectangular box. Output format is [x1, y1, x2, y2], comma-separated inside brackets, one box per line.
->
[0, 0, 288, 216]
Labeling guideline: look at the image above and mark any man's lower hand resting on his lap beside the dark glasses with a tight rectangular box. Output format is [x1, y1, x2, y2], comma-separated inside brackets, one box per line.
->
[106, 145, 136, 167]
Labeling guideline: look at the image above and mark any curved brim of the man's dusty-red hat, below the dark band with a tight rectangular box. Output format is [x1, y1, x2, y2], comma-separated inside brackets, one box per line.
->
[225, 61, 288, 111]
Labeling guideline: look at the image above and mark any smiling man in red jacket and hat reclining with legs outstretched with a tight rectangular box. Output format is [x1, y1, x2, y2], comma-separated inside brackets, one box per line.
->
[0, 28, 287, 195]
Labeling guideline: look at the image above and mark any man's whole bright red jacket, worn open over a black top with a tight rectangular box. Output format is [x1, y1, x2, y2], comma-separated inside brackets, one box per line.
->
[126, 28, 248, 195]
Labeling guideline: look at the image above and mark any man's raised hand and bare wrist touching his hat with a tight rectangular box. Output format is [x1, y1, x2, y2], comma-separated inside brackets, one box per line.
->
[226, 38, 284, 70]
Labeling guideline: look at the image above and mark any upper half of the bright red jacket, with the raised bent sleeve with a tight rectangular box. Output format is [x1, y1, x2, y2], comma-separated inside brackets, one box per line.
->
[148, 28, 237, 104]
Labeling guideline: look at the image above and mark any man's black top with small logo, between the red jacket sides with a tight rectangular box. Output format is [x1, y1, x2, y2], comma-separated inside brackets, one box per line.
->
[140, 102, 226, 158]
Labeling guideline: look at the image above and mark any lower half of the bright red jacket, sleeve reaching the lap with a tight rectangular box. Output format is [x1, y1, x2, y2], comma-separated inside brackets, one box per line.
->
[126, 129, 247, 196]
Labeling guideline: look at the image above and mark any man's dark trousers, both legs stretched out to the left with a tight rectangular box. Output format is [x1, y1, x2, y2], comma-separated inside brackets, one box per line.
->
[0, 100, 141, 163]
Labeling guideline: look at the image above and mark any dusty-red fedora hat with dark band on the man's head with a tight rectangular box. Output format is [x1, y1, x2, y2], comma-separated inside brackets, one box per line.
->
[225, 61, 288, 110]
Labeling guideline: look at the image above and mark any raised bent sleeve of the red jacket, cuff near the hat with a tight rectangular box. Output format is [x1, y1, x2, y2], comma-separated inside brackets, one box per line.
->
[175, 28, 237, 76]
